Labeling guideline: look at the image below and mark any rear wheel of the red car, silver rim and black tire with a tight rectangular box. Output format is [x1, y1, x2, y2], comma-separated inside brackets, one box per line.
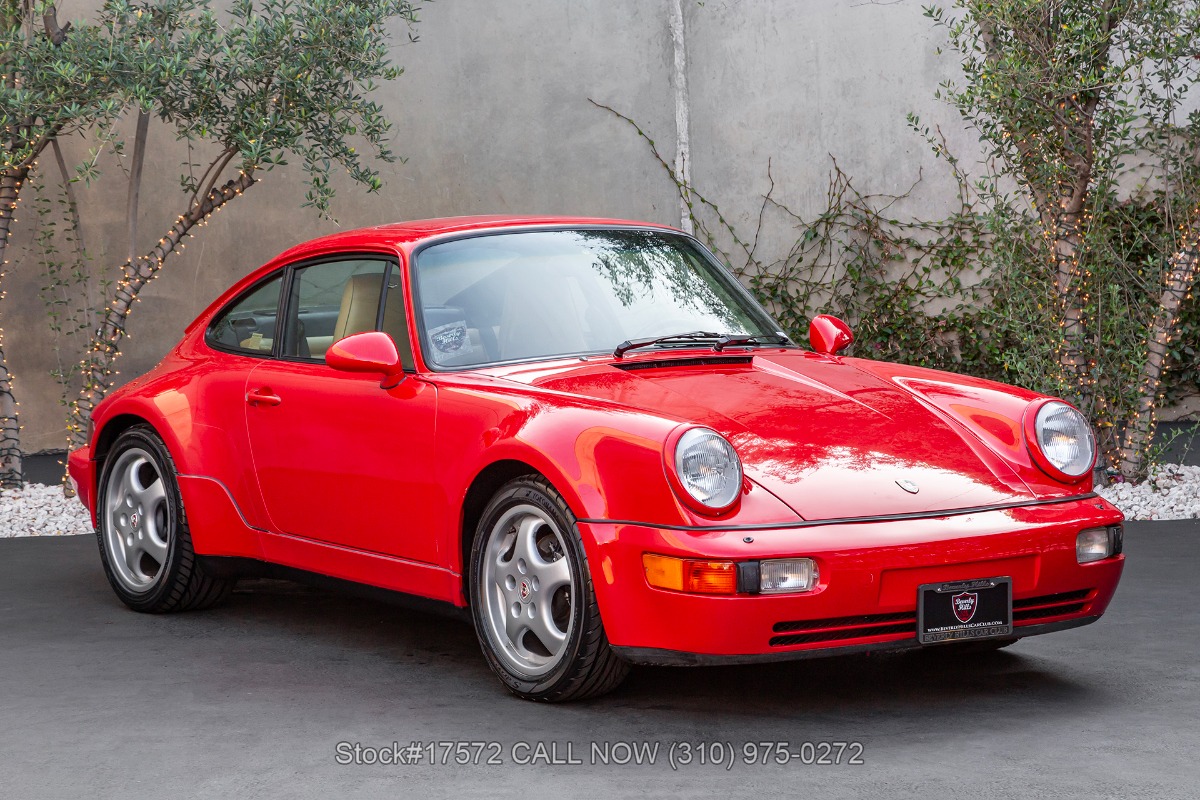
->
[96, 425, 236, 614]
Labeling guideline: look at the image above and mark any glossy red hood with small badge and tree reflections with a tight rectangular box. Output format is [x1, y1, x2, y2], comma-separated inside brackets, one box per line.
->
[506, 350, 1033, 519]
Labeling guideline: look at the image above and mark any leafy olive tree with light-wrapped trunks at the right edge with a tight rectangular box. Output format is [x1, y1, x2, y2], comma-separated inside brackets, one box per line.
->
[925, 0, 1200, 477]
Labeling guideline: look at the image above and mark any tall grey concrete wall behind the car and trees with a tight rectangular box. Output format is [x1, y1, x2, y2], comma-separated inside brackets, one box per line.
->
[0, 0, 976, 452]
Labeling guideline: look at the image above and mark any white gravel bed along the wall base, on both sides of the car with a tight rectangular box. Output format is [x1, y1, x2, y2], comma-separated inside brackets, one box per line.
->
[0, 464, 1200, 539]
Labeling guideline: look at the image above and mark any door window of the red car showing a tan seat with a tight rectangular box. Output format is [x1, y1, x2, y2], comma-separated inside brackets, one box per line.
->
[282, 259, 390, 361]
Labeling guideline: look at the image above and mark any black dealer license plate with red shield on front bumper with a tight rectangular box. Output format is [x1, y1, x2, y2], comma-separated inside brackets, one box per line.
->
[917, 578, 1013, 644]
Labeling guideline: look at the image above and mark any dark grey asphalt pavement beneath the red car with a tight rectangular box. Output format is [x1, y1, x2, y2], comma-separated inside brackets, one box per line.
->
[0, 521, 1200, 800]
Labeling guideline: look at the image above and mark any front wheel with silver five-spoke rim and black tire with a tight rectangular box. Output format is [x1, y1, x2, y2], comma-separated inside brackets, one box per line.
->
[469, 475, 629, 702]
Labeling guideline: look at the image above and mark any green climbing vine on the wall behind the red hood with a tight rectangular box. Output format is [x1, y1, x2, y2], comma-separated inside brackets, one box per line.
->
[595, 95, 1200, 477]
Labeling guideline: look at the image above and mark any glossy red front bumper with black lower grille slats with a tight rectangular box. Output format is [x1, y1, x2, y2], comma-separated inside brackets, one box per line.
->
[580, 497, 1124, 663]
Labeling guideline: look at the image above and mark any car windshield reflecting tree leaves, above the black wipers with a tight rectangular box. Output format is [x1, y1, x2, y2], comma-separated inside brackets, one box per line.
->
[413, 229, 778, 367]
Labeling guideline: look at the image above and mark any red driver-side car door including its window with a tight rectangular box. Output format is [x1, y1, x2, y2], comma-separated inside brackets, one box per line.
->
[246, 255, 442, 564]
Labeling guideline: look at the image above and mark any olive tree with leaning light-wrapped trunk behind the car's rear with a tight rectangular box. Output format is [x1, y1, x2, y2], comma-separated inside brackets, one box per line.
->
[68, 0, 418, 444]
